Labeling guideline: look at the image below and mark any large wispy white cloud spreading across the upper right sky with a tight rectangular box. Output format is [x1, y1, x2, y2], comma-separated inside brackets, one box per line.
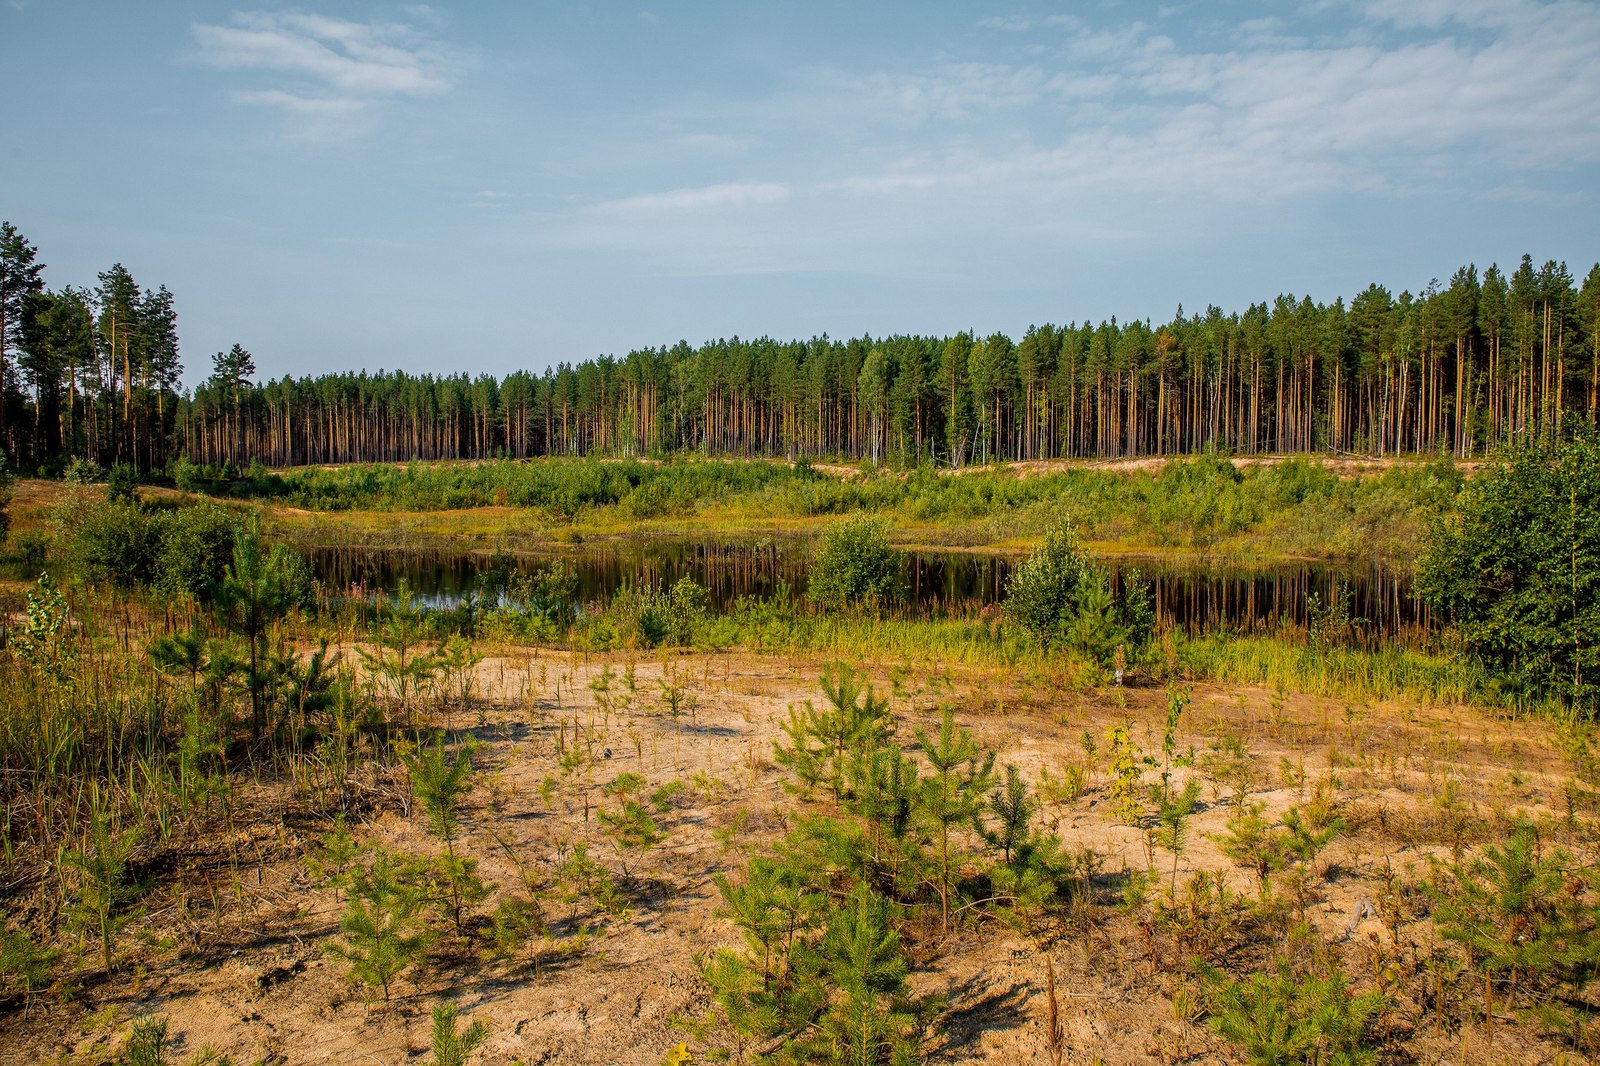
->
[533, 0, 1600, 272]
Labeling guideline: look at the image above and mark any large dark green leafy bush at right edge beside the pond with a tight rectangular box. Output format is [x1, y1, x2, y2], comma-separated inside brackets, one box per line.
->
[1418, 429, 1600, 712]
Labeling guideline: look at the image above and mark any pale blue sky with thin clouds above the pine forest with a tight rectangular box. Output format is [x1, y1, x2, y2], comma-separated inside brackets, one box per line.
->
[0, 0, 1600, 383]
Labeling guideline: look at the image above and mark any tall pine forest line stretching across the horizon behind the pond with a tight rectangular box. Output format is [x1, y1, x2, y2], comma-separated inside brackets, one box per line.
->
[0, 222, 1600, 467]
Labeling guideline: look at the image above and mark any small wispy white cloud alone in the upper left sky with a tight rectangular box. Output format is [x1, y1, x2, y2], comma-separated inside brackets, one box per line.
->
[194, 8, 461, 129]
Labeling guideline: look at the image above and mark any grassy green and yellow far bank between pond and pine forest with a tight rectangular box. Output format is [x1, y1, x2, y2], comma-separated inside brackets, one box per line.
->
[203, 456, 1462, 560]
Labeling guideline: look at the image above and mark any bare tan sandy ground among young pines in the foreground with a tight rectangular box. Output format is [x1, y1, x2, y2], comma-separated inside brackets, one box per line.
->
[0, 651, 1570, 1066]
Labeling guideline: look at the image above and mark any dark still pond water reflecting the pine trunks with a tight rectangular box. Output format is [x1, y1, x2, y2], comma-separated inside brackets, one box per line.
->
[309, 538, 1430, 639]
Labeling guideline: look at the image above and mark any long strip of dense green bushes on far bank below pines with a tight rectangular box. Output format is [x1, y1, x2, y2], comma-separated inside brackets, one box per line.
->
[196, 455, 1461, 557]
